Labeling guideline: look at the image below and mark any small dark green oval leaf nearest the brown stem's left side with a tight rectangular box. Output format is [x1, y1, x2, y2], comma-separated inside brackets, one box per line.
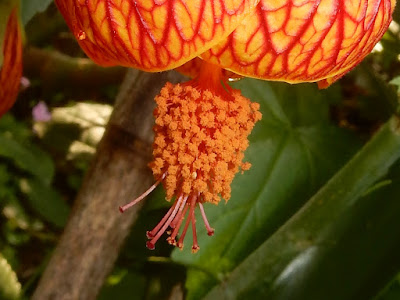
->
[20, 179, 70, 227]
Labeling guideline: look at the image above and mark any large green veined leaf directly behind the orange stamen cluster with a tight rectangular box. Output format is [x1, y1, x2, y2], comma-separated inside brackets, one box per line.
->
[172, 80, 358, 299]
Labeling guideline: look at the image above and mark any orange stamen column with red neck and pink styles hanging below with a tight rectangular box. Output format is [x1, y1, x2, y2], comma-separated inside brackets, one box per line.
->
[120, 62, 261, 252]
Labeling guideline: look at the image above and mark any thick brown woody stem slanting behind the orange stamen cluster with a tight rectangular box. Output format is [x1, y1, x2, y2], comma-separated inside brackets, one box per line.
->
[32, 70, 186, 300]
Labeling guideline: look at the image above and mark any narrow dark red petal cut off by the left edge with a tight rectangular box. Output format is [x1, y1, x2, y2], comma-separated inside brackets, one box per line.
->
[0, 8, 22, 117]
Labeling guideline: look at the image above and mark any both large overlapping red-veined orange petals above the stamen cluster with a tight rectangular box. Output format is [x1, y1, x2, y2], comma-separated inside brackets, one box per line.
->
[56, 0, 396, 87]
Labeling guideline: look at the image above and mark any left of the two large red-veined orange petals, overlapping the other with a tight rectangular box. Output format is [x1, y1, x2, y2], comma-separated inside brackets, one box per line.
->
[56, 0, 259, 71]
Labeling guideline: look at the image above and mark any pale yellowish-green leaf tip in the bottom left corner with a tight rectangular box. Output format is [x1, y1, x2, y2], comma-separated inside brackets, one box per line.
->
[0, 254, 21, 300]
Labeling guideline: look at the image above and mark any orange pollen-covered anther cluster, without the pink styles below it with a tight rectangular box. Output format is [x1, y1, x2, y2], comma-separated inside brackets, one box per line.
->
[150, 66, 261, 203]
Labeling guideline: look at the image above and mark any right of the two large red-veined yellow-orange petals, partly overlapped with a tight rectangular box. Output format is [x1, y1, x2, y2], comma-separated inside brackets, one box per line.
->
[202, 0, 396, 87]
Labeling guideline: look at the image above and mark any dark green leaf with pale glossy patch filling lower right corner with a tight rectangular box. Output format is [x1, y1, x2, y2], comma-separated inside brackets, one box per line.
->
[206, 117, 400, 299]
